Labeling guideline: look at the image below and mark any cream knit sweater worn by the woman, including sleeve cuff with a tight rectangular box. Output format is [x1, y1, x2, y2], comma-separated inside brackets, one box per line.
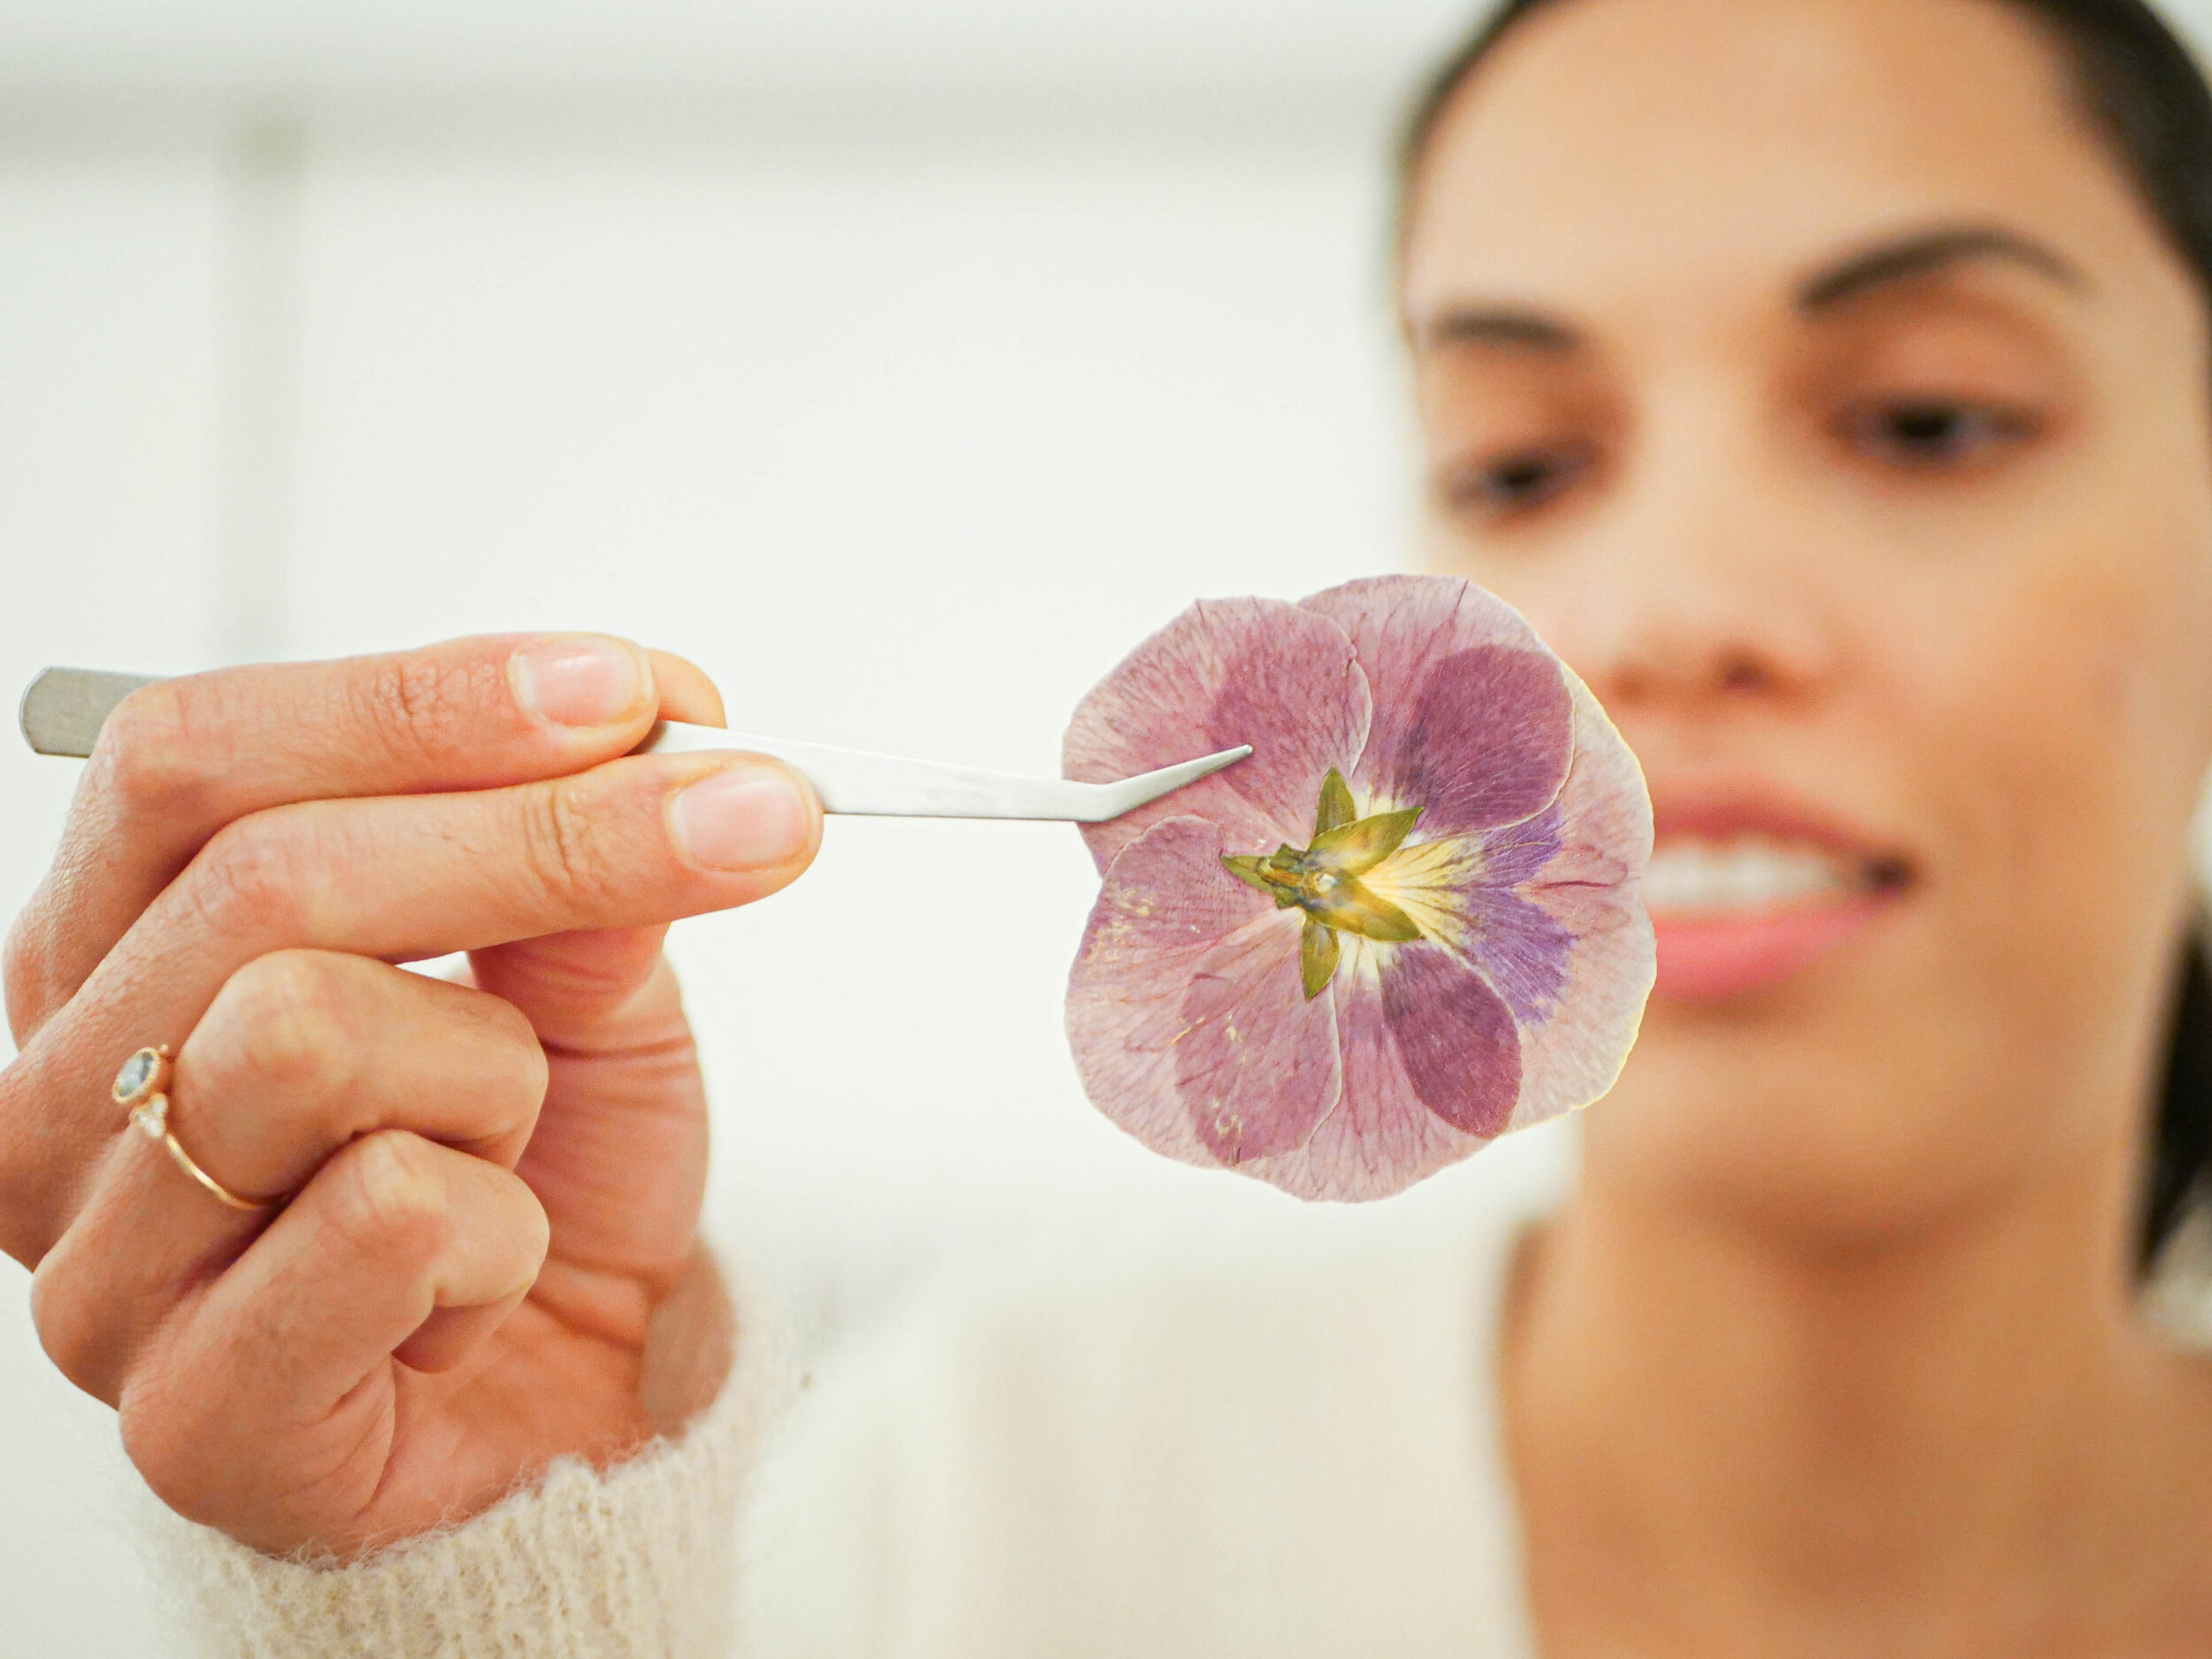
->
[149, 1159, 1555, 1659]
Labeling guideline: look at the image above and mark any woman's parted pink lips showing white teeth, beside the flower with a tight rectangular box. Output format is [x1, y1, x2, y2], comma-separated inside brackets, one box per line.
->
[1644, 796, 1914, 1002]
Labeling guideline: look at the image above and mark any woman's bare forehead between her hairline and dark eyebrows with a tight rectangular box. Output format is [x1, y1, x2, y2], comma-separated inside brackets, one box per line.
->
[1405, 0, 2177, 317]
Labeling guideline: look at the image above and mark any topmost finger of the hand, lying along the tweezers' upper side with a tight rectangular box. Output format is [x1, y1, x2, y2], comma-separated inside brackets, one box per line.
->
[7, 633, 721, 1047]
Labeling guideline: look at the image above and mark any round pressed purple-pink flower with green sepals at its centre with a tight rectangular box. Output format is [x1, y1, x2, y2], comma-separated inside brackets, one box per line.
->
[1066, 578, 1653, 1199]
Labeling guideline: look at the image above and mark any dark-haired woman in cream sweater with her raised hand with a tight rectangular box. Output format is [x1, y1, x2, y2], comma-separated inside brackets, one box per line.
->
[12, 0, 2212, 1657]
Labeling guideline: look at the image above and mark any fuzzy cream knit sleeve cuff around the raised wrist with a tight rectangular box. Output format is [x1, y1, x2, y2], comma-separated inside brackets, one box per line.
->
[142, 1256, 781, 1659]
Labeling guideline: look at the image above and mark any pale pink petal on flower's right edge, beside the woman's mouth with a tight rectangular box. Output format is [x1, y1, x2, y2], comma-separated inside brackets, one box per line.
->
[1473, 672, 1657, 1128]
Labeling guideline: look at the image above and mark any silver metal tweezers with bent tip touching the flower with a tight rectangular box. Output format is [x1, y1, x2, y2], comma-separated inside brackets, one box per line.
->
[22, 668, 1252, 823]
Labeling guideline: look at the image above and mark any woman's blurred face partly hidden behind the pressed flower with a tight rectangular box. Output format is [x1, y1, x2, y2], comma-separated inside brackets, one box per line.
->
[1402, 0, 2212, 1230]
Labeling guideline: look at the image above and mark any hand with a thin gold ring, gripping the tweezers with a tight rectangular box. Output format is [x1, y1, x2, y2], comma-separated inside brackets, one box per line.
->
[0, 637, 821, 1553]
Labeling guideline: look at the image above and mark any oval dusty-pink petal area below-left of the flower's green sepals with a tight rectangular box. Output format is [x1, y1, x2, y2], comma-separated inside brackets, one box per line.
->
[1175, 911, 1343, 1168]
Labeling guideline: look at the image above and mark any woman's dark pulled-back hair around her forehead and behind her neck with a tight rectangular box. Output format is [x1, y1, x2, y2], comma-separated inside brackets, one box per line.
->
[1398, 0, 2212, 1265]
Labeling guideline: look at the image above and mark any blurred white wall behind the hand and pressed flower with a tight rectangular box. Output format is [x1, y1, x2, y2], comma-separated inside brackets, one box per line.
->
[12, 0, 2212, 1655]
